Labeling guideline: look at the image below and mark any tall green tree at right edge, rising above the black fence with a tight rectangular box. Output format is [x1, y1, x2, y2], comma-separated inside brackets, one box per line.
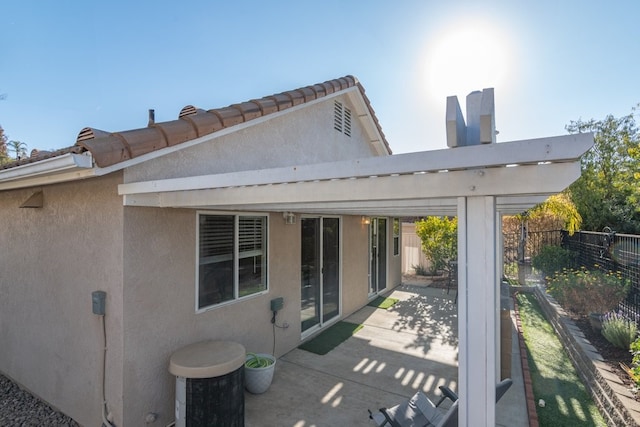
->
[566, 108, 640, 233]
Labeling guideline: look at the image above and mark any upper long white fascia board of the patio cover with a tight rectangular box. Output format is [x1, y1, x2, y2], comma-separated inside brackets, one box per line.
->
[118, 134, 593, 195]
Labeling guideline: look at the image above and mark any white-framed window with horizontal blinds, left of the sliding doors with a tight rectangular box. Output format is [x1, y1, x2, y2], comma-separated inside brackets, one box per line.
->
[196, 213, 267, 310]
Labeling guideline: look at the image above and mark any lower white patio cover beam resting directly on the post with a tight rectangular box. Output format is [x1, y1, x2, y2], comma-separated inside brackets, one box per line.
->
[124, 162, 580, 211]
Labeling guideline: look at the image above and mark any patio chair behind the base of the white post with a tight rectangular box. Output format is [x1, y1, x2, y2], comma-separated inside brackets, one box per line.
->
[369, 378, 513, 427]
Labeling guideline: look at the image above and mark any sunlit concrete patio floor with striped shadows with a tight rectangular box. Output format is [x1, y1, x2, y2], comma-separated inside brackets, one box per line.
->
[245, 283, 529, 427]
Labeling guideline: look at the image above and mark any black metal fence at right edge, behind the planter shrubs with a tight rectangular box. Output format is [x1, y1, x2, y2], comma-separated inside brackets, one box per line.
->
[562, 231, 640, 323]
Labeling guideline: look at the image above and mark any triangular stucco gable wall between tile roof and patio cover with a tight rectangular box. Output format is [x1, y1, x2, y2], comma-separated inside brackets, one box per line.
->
[125, 96, 374, 182]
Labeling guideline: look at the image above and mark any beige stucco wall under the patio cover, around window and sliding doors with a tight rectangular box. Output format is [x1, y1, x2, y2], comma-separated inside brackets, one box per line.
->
[118, 208, 378, 425]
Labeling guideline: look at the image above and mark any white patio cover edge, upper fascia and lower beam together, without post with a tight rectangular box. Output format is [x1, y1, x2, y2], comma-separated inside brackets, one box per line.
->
[118, 134, 593, 216]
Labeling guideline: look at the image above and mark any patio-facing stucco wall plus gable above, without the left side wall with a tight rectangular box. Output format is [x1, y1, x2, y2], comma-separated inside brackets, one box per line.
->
[116, 97, 390, 425]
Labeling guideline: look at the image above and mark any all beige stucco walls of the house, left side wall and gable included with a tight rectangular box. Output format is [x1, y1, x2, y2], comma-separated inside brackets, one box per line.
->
[0, 93, 399, 426]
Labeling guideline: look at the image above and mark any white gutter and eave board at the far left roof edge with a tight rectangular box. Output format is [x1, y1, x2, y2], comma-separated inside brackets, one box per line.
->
[0, 153, 96, 190]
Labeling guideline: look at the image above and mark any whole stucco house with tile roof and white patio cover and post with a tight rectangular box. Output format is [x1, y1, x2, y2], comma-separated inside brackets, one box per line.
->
[0, 76, 593, 427]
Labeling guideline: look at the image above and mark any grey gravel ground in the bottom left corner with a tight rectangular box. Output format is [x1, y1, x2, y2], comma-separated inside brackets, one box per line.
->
[0, 375, 79, 427]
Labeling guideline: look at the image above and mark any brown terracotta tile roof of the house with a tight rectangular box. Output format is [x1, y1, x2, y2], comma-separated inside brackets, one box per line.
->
[0, 75, 391, 169]
